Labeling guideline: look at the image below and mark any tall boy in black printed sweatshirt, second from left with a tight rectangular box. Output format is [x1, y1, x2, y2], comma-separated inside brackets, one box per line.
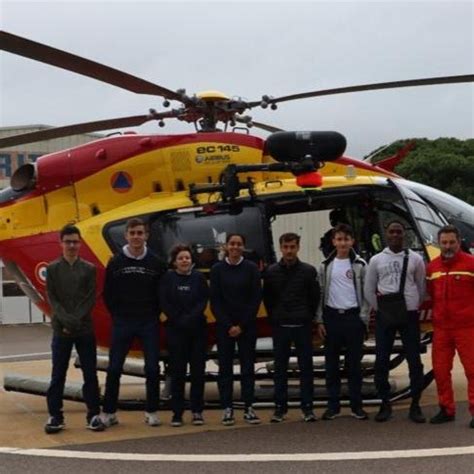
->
[103, 218, 166, 426]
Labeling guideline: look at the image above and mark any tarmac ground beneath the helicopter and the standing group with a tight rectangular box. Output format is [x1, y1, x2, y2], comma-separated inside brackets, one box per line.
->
[0, 325, 474, 474]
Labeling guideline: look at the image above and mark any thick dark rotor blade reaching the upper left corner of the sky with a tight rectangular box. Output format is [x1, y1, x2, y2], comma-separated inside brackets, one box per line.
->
[0, 30, 182, 102]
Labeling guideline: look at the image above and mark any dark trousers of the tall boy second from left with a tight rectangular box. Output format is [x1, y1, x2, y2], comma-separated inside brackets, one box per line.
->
[104, 319, 160, 413]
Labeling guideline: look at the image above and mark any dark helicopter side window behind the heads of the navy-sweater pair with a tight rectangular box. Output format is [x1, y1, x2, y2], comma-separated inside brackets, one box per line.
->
[148, 207, 266, 269]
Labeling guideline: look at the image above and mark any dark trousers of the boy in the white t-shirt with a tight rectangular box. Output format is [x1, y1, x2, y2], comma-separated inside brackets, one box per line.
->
[323, 307, 365, 411]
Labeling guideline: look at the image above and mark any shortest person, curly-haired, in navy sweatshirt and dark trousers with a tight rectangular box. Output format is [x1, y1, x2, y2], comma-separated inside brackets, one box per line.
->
[160, 244, 209, 427]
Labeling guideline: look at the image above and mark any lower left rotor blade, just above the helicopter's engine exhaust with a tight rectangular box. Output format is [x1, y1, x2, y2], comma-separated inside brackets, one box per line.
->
[0, 110, 176, 148]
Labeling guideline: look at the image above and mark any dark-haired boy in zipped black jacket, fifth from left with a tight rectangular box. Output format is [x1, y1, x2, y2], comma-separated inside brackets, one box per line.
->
[263, 232, 320, 423]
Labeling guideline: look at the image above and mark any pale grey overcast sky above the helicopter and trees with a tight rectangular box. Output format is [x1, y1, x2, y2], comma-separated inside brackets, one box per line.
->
[0, 0, 474, 157]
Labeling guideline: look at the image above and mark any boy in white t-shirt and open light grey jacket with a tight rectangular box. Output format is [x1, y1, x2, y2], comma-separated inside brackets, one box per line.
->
[318, 224, 369, 420]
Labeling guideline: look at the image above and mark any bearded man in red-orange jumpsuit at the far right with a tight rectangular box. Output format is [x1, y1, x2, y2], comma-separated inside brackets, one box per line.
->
[426, 225, 474, 428]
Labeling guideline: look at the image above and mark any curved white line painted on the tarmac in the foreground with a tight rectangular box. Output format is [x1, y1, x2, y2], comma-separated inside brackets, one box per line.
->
[0, 446, 474, 463]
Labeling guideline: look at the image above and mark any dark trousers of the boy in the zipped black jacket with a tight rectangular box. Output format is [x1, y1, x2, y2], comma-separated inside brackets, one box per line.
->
[273, 323, 313, 410]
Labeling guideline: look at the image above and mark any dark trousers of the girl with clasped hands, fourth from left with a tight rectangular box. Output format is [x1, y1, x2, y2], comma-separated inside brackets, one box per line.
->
[217, 324, 257, 408]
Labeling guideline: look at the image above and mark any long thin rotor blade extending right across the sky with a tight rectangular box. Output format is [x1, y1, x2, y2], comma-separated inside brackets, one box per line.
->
[248, 74, 474, 107]
